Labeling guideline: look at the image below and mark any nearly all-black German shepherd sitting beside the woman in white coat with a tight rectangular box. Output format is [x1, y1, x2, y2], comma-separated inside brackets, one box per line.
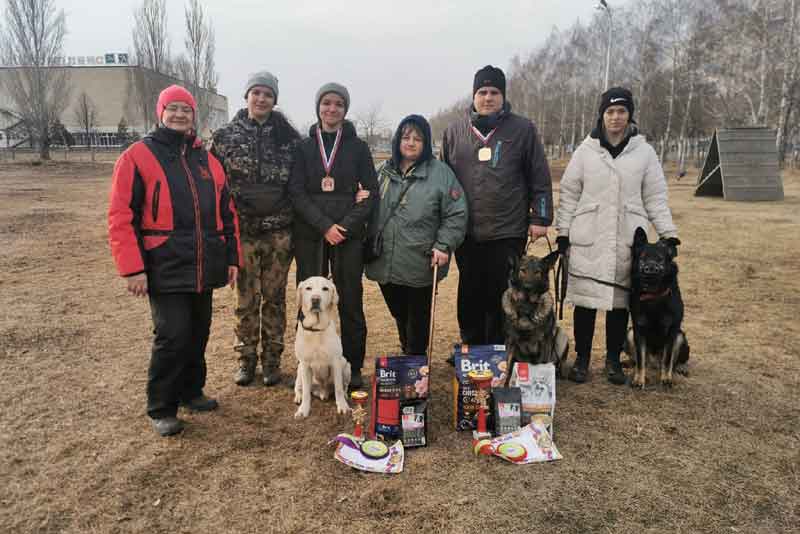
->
[627, 228, 689, 388]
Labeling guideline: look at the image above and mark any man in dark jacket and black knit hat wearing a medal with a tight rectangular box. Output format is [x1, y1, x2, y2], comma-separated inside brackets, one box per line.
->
[442, 65, 553, 345]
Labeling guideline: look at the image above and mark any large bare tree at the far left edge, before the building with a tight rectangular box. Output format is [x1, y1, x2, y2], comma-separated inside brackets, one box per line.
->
[0, 0, 70, 159]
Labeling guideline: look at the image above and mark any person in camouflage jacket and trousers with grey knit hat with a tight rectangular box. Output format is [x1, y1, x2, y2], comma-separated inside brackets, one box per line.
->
[211, 72, 300, 386]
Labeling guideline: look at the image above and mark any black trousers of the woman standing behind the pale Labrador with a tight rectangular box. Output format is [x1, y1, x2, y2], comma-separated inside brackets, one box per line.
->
[294, 238, 367, 374]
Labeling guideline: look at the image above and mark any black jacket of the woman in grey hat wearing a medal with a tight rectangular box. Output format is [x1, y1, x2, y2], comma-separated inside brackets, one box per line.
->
[289, 121, 378, 239]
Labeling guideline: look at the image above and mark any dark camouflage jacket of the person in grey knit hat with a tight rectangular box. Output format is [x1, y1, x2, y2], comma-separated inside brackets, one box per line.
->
[211, 109, 300, 237]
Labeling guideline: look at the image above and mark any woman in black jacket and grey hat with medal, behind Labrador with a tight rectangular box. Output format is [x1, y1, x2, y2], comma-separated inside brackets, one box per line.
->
[289, 83, 378, 388]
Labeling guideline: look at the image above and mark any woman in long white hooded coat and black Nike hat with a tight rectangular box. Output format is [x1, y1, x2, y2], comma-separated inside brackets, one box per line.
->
[556, 87, 680, 384]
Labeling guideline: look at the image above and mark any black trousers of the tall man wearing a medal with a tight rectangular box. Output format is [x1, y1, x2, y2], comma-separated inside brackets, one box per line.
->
[456, 236, 525, 345]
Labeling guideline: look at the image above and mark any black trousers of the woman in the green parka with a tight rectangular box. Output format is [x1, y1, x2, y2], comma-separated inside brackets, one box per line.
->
[380, 284, 433, 354]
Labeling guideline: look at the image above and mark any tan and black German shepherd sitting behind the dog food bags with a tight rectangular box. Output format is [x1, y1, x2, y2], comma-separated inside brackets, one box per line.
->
[502, 252, 569, 382]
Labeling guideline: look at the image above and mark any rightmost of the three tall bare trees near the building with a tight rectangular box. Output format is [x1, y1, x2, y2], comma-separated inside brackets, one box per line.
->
[176, 0, 218, 130]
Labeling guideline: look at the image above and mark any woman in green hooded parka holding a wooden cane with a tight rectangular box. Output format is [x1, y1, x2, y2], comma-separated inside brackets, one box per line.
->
[366, 115, 467, 354]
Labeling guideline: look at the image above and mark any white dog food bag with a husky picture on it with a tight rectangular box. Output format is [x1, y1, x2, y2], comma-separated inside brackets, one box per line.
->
[509, 362, 556, 436]
